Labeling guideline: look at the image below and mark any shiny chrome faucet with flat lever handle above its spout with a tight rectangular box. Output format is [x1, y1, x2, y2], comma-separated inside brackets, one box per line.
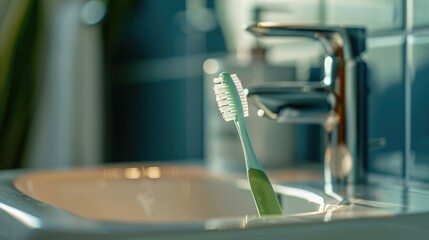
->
[246, 23, 368, 183]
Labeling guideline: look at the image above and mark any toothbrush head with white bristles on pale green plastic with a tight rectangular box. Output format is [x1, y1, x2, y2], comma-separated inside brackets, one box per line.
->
[213, 72, 249, 122]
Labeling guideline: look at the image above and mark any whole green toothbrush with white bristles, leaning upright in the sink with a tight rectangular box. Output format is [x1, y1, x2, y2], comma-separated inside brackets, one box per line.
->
[213, 72, 282, 217]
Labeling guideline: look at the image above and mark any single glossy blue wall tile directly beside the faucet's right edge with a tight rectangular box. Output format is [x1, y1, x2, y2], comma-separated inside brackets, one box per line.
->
[367, 36, 405, 176]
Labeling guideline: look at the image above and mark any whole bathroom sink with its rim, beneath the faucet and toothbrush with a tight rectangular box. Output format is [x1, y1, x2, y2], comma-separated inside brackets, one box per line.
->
[0, 164, 429, 239]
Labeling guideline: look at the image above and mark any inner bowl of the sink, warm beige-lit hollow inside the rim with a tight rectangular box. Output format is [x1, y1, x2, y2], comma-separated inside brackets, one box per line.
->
[14, 166, 339, 223]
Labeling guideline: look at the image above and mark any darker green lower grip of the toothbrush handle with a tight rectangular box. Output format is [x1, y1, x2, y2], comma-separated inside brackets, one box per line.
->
[247, 168, 282, 217]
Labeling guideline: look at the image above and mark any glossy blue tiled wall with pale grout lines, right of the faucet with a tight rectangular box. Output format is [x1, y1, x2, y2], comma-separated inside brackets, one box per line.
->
[362, 0, 429, 181]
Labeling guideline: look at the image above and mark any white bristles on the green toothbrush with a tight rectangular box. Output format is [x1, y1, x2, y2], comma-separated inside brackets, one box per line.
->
[213, 74, 249, 122]
